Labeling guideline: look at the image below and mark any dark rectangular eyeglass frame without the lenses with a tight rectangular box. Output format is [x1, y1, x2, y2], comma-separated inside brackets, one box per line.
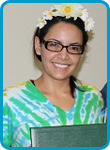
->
[42, 39, 84, 55]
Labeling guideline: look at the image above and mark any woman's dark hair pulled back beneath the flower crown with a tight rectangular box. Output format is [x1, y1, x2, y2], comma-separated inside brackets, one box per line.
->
[33, 16, 88, 97]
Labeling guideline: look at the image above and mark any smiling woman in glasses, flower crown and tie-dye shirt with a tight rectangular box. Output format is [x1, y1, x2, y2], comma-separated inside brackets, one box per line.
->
[3, 3, 104, 147]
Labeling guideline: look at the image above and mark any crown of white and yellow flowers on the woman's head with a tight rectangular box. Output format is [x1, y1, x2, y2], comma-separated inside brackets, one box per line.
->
[37, 3, 95, 31]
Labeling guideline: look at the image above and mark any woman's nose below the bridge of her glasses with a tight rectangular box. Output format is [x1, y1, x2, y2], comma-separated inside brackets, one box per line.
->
[58, 47, 69, 61]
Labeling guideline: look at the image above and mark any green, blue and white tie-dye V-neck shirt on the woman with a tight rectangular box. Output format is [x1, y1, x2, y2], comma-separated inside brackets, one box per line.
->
[3, 80, 104, 147]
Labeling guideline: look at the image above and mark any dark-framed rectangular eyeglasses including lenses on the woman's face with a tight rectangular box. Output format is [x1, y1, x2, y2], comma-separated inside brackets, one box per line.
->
[42, 40, 84, 55]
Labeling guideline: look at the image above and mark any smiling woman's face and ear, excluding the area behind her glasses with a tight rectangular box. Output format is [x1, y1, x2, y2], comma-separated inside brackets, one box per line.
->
[35, 22, 83, 80]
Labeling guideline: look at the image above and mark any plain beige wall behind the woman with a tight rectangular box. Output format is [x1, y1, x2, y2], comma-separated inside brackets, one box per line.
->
[3, 3, 107, 89]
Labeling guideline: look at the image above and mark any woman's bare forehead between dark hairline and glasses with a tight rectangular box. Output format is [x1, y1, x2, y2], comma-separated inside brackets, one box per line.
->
[45, 22, 82, 43]
